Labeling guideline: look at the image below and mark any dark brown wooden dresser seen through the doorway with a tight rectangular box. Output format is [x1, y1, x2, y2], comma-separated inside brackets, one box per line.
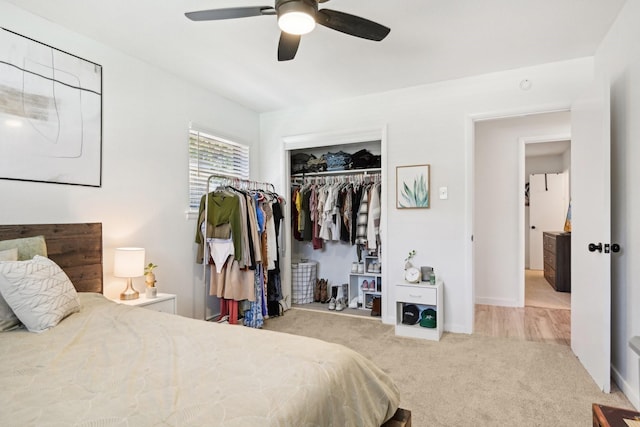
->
[542, 231, 571, 292]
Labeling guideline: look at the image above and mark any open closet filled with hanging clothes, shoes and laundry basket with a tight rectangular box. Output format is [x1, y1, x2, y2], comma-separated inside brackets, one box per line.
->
[285, 130, 393, 321]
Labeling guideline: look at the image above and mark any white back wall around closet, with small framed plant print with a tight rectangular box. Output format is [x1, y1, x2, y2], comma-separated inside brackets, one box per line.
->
[260, 59, 593, 332]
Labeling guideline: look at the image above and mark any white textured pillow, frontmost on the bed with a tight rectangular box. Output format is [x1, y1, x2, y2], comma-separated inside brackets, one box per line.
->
[0, 255, 80, 332]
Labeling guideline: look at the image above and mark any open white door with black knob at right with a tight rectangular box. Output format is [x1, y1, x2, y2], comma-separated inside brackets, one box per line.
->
[571, 78, 611, 393]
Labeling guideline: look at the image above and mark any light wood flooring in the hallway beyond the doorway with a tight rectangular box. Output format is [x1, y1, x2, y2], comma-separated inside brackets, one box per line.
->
[474, 271, 571, 346]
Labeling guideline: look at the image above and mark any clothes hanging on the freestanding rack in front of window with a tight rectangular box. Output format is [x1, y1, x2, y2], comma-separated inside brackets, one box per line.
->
[195, 186, 284, 328]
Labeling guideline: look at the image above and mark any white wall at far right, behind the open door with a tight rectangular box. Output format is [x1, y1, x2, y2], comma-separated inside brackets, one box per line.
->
[595, 1, 640, 408]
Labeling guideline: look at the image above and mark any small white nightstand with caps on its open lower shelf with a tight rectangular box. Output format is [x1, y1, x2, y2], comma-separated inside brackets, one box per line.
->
[395, 282, 444, 341]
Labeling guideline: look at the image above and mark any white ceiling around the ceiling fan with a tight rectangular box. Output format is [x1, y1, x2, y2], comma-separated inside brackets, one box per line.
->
[7, 0, 625, 112]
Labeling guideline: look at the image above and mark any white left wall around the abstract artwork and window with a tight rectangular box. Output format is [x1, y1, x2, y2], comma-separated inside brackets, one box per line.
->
[0, 1, 259, 317]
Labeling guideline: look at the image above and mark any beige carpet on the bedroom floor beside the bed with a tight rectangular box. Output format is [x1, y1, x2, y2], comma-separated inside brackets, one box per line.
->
[265, 309, 632, 427]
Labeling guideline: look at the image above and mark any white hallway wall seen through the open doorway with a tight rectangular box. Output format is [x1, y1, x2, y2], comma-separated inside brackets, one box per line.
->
[473, 111, 571, 307]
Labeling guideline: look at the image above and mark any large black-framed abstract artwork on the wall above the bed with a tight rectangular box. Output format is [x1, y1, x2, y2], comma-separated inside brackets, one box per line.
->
[0, 28, 102, 187]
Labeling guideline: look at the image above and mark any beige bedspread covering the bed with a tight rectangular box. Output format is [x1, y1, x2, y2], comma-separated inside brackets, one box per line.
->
[0, 294, 399, 427]
